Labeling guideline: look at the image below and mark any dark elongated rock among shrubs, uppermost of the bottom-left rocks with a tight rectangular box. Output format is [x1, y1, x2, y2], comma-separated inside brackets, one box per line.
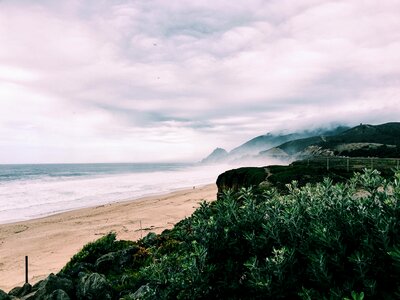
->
[95, 246, 139, 273]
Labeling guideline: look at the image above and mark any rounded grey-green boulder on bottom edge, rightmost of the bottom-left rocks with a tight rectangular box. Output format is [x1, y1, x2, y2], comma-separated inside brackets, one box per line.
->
[76, 273, 113, 300]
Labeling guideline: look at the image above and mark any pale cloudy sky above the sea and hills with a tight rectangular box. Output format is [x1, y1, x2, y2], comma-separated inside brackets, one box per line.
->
[0, 0, 400, 163]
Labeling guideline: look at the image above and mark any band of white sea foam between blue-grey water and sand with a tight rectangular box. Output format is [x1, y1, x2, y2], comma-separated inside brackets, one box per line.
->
[0, 165, 232, 223]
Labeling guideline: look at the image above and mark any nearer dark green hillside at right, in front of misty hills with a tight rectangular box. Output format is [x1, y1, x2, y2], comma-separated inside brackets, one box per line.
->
[278, 122, 400, 157]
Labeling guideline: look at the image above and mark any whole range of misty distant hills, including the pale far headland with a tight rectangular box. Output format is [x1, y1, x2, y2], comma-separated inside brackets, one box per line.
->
[202, 122, 400, 164]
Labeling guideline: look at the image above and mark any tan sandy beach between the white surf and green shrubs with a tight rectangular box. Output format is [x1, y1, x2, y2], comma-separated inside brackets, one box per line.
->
[0, 184, 217, 291]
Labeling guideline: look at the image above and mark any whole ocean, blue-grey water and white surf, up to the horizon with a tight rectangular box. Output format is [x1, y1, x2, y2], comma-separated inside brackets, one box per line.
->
[0, 163, 232, 224]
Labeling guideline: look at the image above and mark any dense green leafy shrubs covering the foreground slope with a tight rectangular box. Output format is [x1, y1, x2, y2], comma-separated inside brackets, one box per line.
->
[7, 170, 400, 299]
